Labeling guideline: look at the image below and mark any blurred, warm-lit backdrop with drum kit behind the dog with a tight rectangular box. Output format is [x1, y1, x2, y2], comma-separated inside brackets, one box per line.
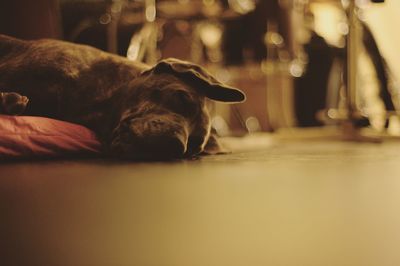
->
[0, 0, 400, 139]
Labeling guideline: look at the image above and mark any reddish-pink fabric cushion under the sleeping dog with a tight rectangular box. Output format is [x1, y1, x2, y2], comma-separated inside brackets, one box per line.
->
[0, 115, 101, 158]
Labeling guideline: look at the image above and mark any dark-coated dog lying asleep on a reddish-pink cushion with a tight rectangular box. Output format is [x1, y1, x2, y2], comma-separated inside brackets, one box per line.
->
[0, 35, 245, 159]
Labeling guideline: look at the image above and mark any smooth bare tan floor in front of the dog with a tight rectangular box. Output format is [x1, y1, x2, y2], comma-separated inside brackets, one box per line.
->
[0, 128, 400, 266]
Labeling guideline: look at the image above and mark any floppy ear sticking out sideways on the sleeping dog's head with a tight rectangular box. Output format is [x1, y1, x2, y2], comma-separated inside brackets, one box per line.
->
[145, 58, 246, 103]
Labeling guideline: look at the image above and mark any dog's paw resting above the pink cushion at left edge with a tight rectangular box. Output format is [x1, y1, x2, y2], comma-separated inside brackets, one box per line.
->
[0, 92, 29, 115]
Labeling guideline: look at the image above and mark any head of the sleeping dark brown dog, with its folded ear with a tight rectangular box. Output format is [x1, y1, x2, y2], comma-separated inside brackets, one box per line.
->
[111, 59, 245, 159]
